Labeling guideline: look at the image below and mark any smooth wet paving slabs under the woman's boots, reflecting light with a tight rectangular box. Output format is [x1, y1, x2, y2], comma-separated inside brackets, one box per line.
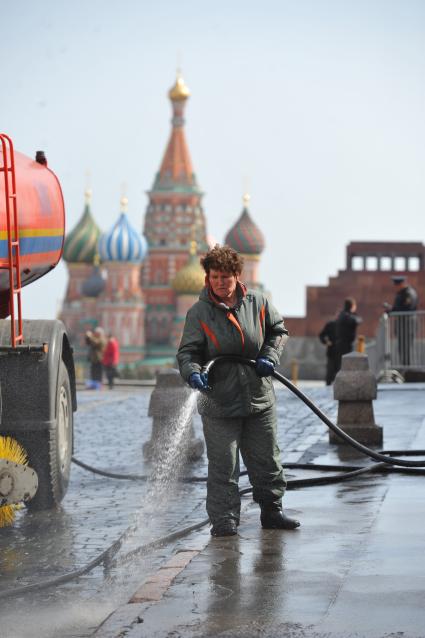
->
[95, 384, 425, 638]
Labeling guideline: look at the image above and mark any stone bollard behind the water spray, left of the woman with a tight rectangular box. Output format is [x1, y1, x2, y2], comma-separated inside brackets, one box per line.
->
[143, 368, 204, 462]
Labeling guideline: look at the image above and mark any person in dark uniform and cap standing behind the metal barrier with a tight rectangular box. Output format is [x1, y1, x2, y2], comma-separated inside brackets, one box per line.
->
[390, 275, 418, 366]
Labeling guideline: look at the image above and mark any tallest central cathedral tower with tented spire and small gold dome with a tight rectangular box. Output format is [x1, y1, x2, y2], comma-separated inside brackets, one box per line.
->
[142, 74, 208, 357]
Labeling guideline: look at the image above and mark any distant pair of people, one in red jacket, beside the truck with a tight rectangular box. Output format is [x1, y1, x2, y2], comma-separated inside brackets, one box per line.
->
[86, 326, 120, 390]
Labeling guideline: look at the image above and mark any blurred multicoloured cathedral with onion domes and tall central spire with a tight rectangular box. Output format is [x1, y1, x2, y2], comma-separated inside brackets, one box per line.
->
[60, 75, 264, 376]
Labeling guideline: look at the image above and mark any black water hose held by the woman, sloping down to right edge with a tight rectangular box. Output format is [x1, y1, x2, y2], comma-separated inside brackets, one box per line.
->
[202, 354, 425, 467]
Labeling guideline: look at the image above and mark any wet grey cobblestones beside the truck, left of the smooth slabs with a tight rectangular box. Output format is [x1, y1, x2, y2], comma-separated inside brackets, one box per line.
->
[0, 387, 336, 638]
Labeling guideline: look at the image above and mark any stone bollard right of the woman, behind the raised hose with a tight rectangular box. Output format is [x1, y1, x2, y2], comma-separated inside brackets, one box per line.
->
[329, 352, 383, 445]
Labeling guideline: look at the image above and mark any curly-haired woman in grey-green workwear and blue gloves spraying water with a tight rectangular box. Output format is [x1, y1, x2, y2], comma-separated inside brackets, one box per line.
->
[177, 245, 300, 536]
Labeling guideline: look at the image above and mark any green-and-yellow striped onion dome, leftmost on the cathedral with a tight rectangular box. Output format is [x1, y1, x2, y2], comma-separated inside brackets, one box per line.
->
[63, 189, 101, 264]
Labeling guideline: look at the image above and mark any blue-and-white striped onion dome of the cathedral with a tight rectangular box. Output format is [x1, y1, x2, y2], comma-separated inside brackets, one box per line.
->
[99, 197, 148, 262]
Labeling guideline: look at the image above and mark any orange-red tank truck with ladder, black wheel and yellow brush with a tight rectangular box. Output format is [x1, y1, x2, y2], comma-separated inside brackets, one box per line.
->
[0, 134, 77, 526]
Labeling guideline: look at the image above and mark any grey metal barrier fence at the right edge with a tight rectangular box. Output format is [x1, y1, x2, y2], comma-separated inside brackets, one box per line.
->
[368, 310, 425, 381]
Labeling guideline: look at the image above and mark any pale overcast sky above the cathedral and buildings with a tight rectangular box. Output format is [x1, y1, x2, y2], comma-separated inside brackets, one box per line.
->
[0, 0, 425, 318]
